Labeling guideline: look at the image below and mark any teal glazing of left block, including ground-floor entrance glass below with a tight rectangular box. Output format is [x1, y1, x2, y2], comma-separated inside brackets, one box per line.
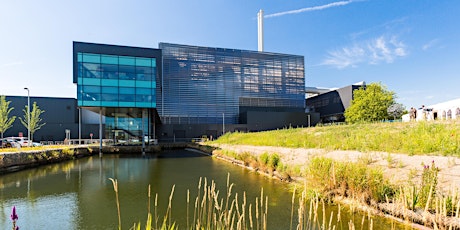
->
[77, 52, 157, 142]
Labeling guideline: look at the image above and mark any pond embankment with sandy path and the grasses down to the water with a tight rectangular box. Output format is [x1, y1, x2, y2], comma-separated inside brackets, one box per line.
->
[190, 145, 460, 229]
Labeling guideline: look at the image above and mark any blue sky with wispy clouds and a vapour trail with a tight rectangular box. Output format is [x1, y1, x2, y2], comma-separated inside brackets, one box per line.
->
[0, 0, 460, 108]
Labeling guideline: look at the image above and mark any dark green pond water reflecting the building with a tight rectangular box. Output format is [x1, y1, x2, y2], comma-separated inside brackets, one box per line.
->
[0, 150, 410, 229]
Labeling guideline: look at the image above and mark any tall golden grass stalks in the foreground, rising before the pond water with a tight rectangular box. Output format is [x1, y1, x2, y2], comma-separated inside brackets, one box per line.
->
[109, 175, 373, 230]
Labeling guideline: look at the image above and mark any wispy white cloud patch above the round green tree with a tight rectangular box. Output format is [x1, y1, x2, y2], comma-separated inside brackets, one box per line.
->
[322, 36, 407, 69]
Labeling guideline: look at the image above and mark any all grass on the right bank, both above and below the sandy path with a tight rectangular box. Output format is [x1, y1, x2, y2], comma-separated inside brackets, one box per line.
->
[212, 120, 460, 229]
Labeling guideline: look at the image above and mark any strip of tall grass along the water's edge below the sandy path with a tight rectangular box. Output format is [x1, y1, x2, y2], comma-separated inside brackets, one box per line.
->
[214, 147, 460, 229]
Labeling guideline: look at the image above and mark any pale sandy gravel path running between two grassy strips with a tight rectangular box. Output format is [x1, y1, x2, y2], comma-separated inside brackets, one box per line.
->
[214, 145, 460, 190]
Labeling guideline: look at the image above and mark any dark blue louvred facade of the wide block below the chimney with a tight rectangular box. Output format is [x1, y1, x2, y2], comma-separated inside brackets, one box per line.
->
[157, 43, 305, 124]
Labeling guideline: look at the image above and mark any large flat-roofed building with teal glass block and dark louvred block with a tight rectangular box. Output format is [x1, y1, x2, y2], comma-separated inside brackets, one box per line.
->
[73, 42, 308, 140]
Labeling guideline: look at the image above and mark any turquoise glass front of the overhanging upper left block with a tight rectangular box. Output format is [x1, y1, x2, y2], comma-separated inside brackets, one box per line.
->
[77, 52, 157, 108]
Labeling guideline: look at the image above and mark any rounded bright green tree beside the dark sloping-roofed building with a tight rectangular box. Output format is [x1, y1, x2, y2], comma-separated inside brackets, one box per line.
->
[344, 83, 395, 123]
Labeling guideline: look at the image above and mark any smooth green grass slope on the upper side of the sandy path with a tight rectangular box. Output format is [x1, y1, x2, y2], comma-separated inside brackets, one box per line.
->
[212, 120, 460, 156]
